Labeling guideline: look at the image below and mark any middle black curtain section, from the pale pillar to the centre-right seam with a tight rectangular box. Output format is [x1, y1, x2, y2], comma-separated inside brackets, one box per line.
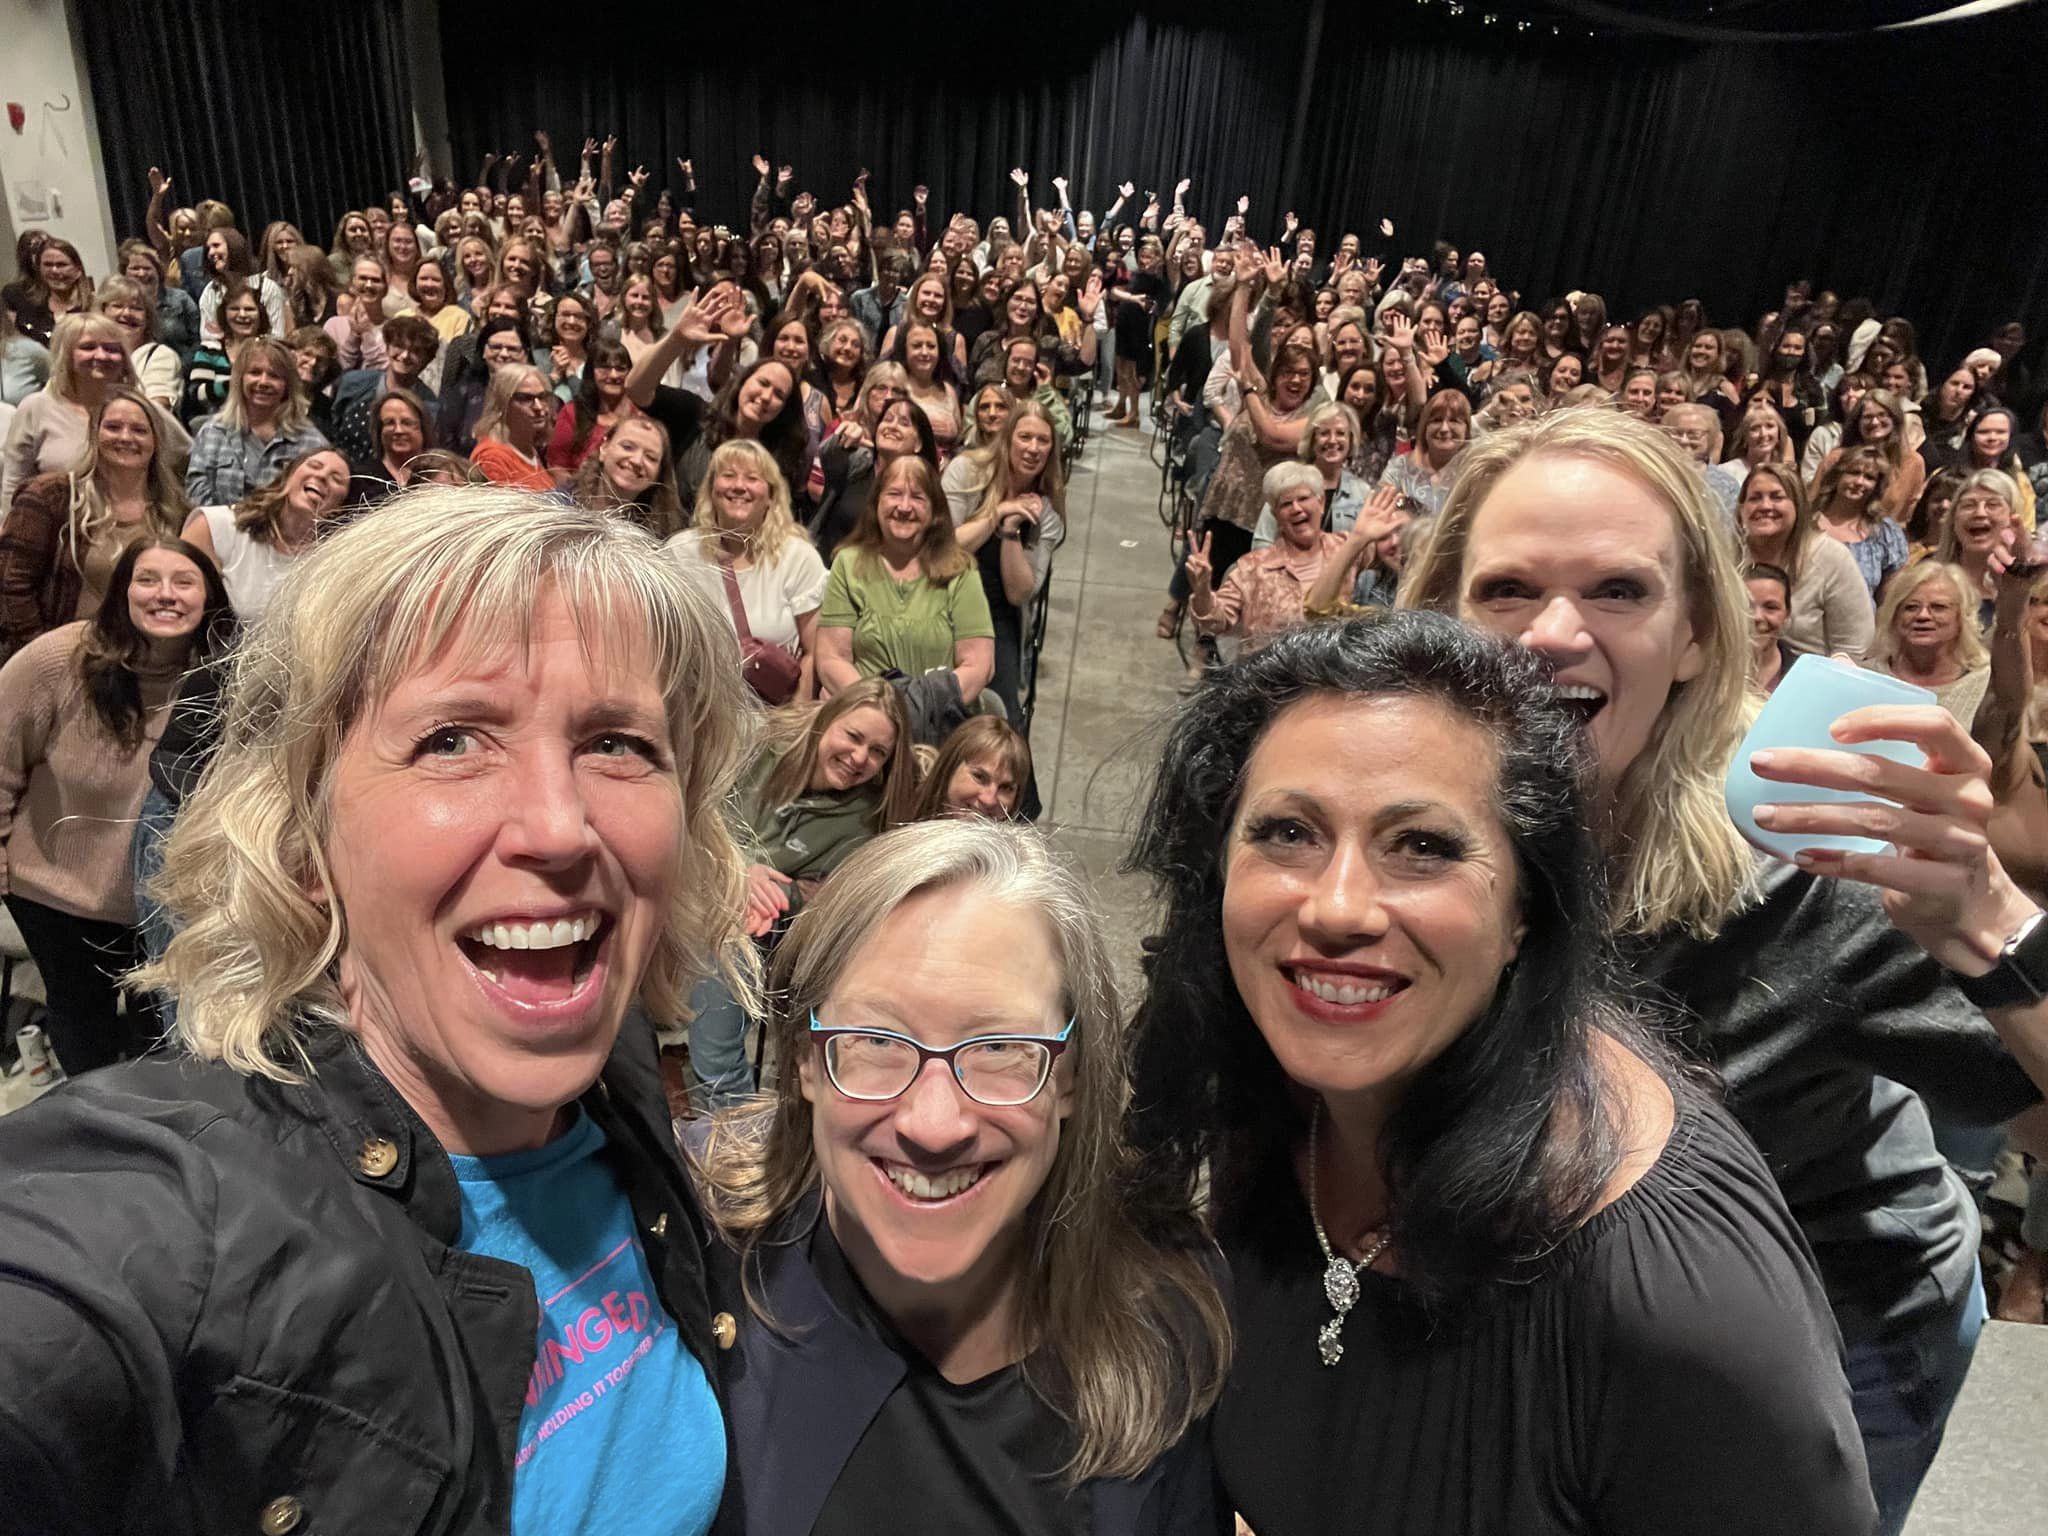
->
[440, 0, 1305, 243]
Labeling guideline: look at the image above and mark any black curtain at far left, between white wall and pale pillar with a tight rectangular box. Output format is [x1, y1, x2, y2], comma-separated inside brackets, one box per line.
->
[76, 0, 414, 256]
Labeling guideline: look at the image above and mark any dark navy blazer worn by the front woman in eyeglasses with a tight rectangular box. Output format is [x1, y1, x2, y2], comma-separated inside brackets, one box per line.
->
[707, 1198, 1233, 1536]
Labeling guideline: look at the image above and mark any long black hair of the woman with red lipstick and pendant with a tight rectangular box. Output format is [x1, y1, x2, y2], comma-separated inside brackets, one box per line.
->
[1128, 612, 1677, 1305]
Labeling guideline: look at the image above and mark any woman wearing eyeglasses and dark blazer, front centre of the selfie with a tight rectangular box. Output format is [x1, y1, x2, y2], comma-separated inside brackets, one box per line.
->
[692, 819, 1231, 1536]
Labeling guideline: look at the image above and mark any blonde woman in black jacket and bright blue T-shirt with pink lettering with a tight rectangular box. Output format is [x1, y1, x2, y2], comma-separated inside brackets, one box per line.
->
[0, 487, 752, 1534]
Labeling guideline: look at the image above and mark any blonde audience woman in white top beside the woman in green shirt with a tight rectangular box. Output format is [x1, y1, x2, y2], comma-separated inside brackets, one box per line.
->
[668, 438, 827, 705]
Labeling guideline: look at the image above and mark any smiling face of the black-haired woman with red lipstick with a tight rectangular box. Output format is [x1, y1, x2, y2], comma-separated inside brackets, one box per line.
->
[1223, 694, 1520, 1104]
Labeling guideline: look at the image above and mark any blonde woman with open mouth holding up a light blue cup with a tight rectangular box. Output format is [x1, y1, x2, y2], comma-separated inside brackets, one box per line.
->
[1401, 412, 2036, 1532]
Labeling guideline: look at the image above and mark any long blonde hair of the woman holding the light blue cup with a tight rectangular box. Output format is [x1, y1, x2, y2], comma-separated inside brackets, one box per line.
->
[1399, 408, 1753, 938]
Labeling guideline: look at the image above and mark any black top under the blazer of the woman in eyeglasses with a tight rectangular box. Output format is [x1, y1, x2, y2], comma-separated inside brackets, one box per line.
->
[811, 1221, 1090, 1536]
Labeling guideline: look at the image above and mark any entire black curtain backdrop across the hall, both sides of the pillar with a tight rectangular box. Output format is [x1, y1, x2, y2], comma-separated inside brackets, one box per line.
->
[80, 0, 2048, 367]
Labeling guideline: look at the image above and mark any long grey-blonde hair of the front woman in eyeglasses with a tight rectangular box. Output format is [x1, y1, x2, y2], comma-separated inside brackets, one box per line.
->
[700, 817, 1231, 1483]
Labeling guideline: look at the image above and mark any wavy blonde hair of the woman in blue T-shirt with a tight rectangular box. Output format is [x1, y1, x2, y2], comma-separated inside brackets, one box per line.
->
[137, 485, 756, 1081]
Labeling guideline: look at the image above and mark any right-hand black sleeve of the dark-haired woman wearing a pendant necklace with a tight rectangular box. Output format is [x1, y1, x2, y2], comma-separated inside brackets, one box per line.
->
[1573, 1114, 1876, 1536]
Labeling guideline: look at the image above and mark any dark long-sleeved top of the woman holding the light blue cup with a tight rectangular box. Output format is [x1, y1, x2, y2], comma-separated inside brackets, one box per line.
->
[1628, 856, 2040, 1348]
